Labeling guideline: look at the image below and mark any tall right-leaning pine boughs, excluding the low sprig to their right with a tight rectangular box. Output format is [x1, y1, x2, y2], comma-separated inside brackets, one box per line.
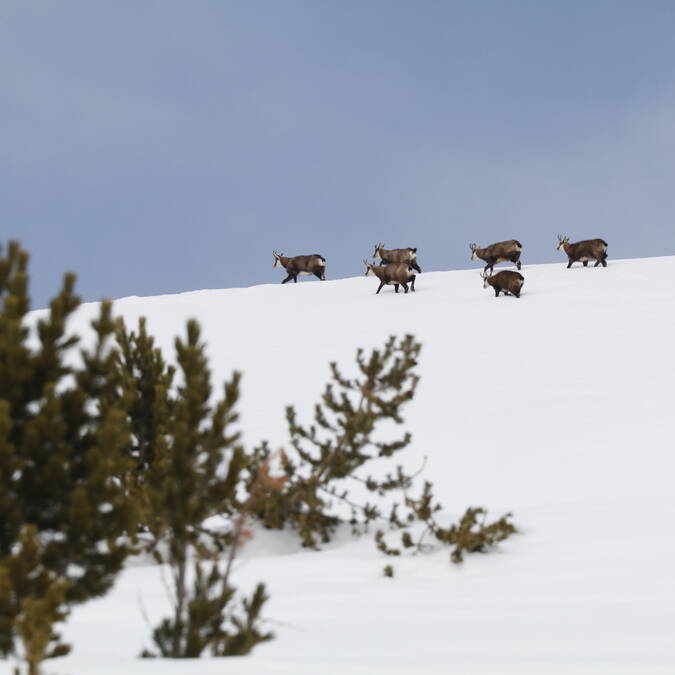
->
[249, 335, 420, 547]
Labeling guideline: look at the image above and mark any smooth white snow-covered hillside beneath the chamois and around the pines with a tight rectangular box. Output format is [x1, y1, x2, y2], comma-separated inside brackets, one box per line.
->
[35, 257, 675, 675]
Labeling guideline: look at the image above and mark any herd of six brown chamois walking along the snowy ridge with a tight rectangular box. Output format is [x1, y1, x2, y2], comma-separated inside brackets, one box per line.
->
[273, 235, 607, 298]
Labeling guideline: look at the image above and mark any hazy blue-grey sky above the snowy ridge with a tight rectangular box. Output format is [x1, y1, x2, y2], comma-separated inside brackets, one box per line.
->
[0, 0, 675, 307]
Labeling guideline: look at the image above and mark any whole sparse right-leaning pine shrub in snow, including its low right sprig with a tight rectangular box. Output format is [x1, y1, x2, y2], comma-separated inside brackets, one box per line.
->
[236, 328, 515, 562]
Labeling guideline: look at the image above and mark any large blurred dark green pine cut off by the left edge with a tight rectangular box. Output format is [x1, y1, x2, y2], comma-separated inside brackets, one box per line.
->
[0, 242, 135, 667]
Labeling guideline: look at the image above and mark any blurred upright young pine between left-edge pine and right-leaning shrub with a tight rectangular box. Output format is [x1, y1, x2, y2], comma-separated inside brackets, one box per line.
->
[128, 321, 272, 658]
